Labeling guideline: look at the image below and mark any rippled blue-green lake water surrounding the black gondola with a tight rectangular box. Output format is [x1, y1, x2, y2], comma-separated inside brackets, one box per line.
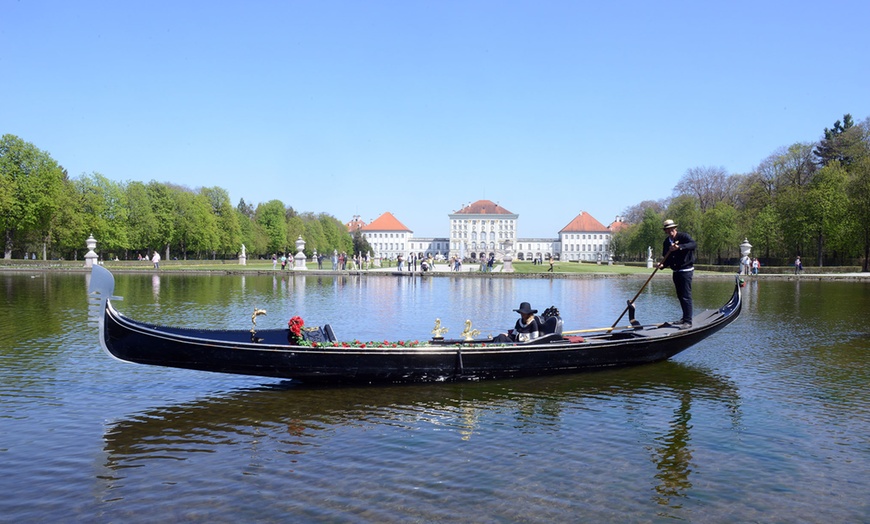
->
[0, 273, 870, 523]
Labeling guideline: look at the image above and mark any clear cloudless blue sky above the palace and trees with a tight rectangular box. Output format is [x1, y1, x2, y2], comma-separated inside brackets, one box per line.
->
[0, 0, 870, 237]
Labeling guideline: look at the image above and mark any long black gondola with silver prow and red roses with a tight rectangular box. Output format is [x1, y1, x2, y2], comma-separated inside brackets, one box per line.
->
[89, 265, 741, 384]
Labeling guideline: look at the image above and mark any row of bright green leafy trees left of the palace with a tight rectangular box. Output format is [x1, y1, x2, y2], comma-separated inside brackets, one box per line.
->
[0, 134, 371, 260]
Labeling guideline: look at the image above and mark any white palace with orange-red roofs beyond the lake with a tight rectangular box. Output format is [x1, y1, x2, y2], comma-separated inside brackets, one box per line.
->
[347, 200, 623, 262]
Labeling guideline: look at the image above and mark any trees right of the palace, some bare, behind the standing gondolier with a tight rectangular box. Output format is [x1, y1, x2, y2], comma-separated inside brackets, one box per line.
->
[611, 114, 870, 271]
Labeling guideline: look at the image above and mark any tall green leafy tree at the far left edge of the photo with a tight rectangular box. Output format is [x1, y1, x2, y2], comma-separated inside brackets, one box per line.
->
[0, 134, 66, 260]
